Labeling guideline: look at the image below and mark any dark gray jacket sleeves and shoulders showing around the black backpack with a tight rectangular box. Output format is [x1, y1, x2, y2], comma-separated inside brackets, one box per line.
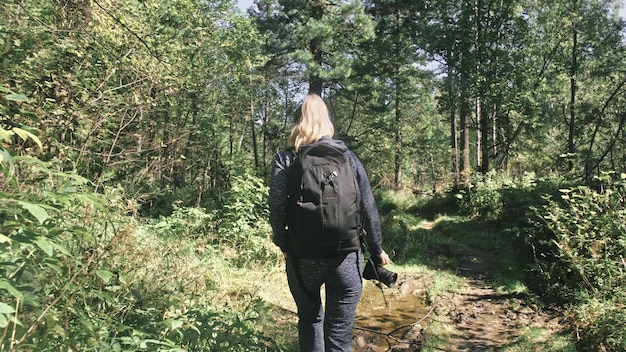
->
[268, 136, 383, 256]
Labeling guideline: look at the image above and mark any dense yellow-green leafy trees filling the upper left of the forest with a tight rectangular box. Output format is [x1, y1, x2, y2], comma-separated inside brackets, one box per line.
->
[0, 0, 262, 206]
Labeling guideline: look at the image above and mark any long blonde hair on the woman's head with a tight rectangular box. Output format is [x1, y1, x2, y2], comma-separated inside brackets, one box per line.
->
[287, 94, 335, 152]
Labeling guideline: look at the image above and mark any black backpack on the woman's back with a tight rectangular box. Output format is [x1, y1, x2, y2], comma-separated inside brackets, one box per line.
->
[287, 142, 361, 258]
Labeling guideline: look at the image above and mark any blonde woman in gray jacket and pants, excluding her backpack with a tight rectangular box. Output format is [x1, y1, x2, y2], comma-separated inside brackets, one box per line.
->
[269, 94, 389, 352]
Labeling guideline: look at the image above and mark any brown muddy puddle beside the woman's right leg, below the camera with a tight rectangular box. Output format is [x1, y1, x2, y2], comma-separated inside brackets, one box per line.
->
[355, 278, 429, 352]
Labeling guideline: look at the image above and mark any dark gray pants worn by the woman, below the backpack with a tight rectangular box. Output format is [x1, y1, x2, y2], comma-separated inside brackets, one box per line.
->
[287, 252, 363, 352]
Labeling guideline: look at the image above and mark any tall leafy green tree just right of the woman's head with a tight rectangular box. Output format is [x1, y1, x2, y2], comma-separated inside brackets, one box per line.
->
[324, 1, 440, 189]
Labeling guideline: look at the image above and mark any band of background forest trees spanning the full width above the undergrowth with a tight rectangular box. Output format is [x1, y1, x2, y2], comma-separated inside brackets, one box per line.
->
[0, 0, 626, 204]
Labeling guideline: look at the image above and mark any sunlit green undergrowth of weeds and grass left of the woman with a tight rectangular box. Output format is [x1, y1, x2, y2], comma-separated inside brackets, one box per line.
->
[0, 158, 280, 351]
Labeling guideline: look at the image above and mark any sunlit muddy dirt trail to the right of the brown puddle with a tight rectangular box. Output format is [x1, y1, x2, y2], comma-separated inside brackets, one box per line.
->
[355, 222, 561, 352]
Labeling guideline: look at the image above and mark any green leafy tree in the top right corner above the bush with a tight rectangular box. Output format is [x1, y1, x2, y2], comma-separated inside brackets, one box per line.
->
[528, 0, 626, 182]
